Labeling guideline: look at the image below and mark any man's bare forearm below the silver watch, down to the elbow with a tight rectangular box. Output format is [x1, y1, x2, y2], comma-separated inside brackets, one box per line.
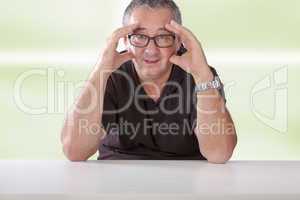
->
[195, 89, 237, 163]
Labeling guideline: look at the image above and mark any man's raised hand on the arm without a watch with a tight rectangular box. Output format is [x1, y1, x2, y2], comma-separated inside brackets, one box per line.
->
[97, 24, 138, 71]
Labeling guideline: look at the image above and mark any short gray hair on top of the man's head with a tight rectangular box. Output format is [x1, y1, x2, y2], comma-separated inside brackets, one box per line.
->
[123, 0, 182, 25]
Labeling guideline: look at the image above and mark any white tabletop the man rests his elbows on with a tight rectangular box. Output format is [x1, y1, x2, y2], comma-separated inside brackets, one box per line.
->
[0, 160, 300, 200]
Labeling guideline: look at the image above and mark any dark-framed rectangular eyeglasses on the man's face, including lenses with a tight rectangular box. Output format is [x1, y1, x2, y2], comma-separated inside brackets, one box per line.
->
[128, 34, 176, 48]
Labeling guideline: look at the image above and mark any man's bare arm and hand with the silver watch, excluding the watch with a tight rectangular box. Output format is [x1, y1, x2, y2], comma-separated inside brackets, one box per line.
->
[166, 21, 237, 163]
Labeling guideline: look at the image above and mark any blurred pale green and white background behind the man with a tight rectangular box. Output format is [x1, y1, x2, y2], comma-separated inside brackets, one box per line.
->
[0, 0, 300, 160]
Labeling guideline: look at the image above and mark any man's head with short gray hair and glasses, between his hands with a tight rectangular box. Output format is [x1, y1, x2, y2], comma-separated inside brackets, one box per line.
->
[123, 0, 182, 79]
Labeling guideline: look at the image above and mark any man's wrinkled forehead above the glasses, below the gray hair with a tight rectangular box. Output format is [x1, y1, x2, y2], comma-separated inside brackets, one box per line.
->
[129, 7, 172, 34]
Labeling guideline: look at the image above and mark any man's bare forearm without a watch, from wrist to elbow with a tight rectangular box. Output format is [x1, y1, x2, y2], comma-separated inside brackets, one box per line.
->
[62, 67, 109, 161]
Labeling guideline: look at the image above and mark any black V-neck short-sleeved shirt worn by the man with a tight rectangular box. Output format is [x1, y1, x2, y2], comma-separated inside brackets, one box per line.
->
[98, 61, 224, 160]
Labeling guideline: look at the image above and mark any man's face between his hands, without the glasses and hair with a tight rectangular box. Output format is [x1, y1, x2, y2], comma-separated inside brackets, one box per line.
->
[126, 7, 179, 80]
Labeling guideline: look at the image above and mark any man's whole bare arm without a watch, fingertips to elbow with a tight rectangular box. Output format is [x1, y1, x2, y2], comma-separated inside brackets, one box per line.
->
[61, 24, 138, 161]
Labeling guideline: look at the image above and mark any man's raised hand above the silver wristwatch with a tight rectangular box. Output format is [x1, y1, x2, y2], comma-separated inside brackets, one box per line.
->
[166, 20, 213, 83]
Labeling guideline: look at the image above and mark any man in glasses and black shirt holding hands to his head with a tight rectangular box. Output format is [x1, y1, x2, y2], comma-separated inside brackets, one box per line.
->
[62, 0, 237, 163]
